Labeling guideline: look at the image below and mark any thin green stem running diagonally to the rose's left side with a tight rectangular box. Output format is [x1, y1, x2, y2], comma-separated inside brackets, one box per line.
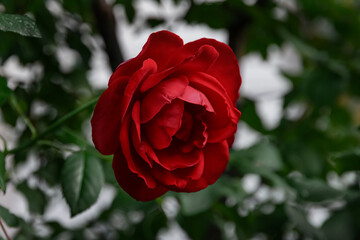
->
[7, 97, 99, 154]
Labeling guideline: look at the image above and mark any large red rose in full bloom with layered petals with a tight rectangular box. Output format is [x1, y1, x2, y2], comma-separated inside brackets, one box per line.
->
[91, 31, 241, 201]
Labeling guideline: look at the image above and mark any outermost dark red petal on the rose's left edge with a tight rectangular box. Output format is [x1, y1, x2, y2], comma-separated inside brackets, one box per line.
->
[91, 77, 128, 155]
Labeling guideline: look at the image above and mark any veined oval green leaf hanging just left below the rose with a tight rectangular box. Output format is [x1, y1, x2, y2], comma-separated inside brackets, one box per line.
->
[61, 152, 104, 216]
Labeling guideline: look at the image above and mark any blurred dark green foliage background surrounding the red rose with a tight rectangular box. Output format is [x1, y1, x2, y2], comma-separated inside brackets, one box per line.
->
[0, 0, 360, 240]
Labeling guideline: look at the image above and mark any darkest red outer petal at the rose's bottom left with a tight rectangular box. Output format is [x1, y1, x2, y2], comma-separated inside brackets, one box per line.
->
[113, 151, 168, 201]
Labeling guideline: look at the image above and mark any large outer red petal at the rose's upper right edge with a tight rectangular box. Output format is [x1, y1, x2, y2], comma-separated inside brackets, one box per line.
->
[183, 38, 241, 105]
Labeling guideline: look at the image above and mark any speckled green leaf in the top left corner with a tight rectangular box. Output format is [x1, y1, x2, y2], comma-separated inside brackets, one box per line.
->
[0, 14, 41, 38]
